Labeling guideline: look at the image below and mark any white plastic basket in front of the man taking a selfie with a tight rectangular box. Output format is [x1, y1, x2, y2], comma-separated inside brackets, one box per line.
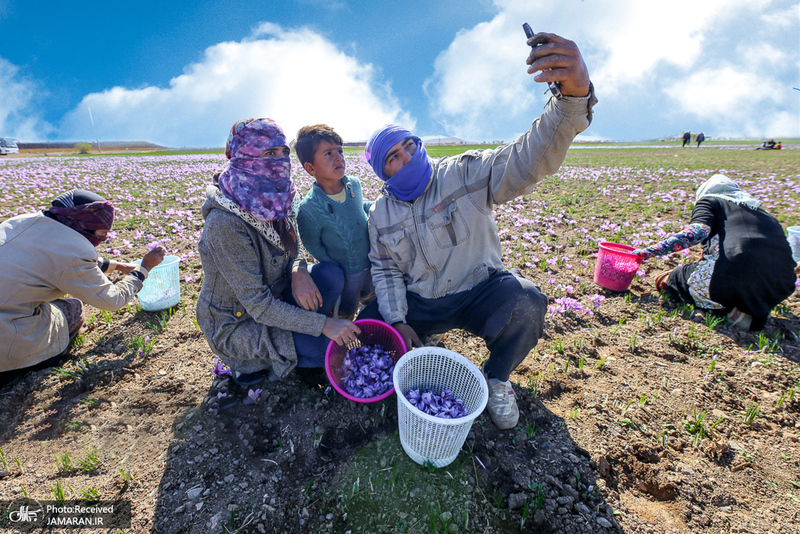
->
[392, 347, 489, 467]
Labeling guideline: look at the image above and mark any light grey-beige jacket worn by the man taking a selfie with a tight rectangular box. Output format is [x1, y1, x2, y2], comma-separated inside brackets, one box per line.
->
[369, 93, 596, 324]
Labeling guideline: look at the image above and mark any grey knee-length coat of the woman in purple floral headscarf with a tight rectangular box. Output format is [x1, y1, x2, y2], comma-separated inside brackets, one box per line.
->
[197, 191, 325, 379]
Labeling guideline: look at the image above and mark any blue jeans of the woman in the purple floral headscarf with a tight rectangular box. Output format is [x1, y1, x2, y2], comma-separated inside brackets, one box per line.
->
[283, 262, 344, 367]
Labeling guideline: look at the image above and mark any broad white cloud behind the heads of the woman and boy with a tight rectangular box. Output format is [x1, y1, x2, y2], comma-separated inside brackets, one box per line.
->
[60, 23, 415, 146]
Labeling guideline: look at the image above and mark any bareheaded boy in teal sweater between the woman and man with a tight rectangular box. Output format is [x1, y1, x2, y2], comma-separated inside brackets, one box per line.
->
[295, 124, 375, 319]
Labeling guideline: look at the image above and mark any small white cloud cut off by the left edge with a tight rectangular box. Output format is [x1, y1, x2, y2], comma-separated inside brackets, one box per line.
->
[0, 57, 52, 141]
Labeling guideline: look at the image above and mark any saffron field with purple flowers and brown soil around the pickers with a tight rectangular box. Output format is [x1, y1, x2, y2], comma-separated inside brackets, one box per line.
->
[0, 145, 800, 533]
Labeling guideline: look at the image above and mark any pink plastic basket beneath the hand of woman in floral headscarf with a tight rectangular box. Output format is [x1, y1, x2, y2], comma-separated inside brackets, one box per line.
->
[325, 319, 406, 403]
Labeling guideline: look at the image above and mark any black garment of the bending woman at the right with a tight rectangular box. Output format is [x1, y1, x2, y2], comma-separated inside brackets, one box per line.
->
[667, 197, 797, 330]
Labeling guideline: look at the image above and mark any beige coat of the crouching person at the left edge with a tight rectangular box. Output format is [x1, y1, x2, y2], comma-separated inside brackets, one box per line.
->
[0, 212, 142, 371]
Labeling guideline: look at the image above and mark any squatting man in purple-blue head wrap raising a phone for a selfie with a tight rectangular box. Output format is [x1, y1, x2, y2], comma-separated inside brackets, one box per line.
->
[359, 33, 596, 429]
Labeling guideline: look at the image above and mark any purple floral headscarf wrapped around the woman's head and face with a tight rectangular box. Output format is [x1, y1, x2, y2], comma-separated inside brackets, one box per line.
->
[219, 119, 295, 221]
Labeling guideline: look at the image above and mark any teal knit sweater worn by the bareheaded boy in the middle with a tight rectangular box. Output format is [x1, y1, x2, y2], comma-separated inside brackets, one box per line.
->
[297, 176, 373, 275]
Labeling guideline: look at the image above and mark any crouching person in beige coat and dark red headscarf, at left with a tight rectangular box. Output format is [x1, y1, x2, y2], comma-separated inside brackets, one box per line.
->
[0, 189, 165, 371]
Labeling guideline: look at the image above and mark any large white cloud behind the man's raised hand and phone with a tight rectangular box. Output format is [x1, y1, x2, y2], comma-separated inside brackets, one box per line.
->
[425, 0, 800, 140]
